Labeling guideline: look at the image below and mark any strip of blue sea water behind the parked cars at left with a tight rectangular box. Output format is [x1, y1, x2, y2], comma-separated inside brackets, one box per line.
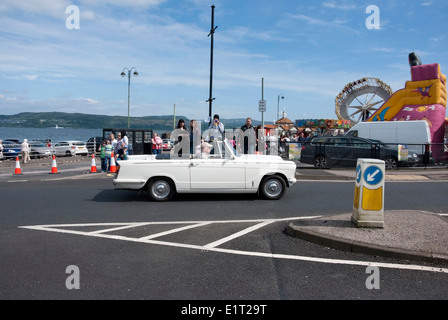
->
[0, 127, 103, 143]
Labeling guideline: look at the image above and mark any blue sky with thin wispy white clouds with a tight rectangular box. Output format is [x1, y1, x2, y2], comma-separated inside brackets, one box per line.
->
[0, 0, 448, 121]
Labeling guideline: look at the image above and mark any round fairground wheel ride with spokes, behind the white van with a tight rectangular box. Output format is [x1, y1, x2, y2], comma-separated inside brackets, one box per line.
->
[335, 78, 393, 125]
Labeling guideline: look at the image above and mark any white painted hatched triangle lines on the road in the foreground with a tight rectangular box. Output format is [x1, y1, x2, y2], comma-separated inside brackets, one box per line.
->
[19, 218, 448, 273]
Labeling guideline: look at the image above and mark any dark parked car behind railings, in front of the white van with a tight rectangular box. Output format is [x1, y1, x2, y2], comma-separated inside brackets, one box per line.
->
[300, 136, 419, 169]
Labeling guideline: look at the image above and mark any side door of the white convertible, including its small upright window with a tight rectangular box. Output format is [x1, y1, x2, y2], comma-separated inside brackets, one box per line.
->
[190, 141, 246, 192]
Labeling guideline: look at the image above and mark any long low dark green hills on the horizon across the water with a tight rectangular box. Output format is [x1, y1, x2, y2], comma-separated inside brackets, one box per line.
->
[0, 112, 272, 132]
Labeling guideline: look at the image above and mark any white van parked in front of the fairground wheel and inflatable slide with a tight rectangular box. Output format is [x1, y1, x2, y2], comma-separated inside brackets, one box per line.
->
[345, 120, 431, 154]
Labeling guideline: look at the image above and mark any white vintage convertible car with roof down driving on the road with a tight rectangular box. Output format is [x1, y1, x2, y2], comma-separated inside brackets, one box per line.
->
[113, 140, 296, 201]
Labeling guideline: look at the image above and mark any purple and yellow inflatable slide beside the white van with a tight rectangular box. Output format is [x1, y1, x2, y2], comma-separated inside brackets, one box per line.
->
[366, 53, 447, 161]
